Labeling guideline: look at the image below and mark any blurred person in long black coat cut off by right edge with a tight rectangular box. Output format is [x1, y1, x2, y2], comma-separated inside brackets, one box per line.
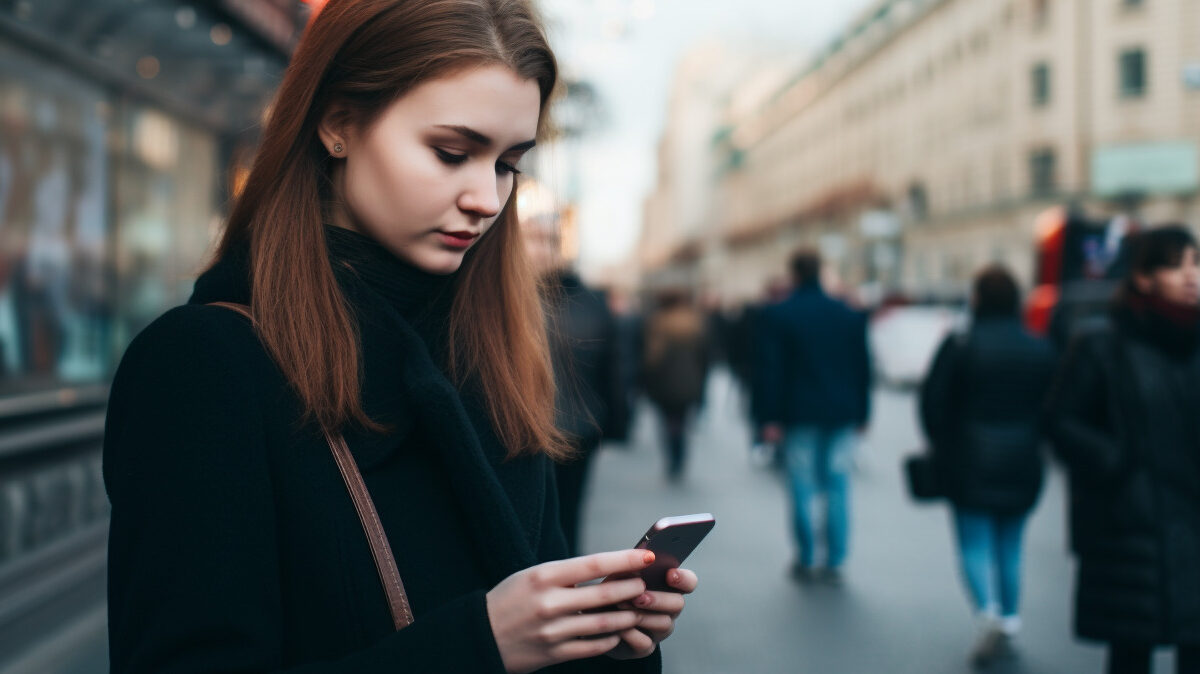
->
[1049, 225, 1200, 674]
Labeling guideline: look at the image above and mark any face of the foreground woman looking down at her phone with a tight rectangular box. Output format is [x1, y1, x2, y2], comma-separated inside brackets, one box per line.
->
[320, 65, 541, 273]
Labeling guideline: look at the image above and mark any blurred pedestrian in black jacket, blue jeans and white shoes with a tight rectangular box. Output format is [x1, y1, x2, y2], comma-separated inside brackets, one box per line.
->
[920, 266, 1054, 666]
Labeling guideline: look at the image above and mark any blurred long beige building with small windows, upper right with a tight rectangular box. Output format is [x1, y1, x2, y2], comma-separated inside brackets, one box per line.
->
[642, 0, 1200, 299]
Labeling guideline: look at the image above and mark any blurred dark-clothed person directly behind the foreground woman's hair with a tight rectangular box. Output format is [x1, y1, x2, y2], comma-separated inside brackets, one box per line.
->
[530, 208, 629, 556]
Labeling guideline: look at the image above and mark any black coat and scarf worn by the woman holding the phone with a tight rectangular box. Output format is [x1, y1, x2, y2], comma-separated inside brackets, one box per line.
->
[103, 228, 660, 674]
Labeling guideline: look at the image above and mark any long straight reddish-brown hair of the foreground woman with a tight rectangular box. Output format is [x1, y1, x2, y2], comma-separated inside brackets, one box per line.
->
[216, 0, 568, 458]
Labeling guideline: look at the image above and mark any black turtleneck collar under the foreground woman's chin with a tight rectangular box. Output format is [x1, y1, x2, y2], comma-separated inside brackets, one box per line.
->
[325, 224, 455, 326]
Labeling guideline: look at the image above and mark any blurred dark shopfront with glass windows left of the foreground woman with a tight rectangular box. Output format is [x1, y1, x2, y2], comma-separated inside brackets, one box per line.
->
[0, 0, 308, 670]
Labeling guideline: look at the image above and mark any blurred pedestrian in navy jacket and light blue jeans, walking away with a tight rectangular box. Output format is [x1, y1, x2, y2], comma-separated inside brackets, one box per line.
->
[760, 251, 871, 584]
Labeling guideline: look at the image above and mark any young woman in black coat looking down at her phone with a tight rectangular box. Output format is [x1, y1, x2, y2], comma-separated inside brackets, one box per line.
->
[104, 0, 697, 673]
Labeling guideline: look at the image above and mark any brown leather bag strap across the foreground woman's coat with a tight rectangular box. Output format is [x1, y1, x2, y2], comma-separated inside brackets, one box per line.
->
[209, 302, 413, 631]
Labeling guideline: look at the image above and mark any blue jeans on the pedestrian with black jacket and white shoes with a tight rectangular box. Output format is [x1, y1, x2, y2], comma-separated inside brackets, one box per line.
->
[954, 508, 1027, 618]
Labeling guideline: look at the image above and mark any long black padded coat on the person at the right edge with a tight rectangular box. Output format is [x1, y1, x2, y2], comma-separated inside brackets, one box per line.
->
[1049, 303, 1200, 645]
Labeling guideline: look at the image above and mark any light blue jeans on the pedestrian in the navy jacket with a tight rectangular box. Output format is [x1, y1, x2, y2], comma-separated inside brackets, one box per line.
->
[784, 426, 854, 568]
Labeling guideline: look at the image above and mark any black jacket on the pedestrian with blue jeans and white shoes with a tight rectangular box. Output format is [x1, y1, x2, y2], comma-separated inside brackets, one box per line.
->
[920, 315, 1054, 514]
